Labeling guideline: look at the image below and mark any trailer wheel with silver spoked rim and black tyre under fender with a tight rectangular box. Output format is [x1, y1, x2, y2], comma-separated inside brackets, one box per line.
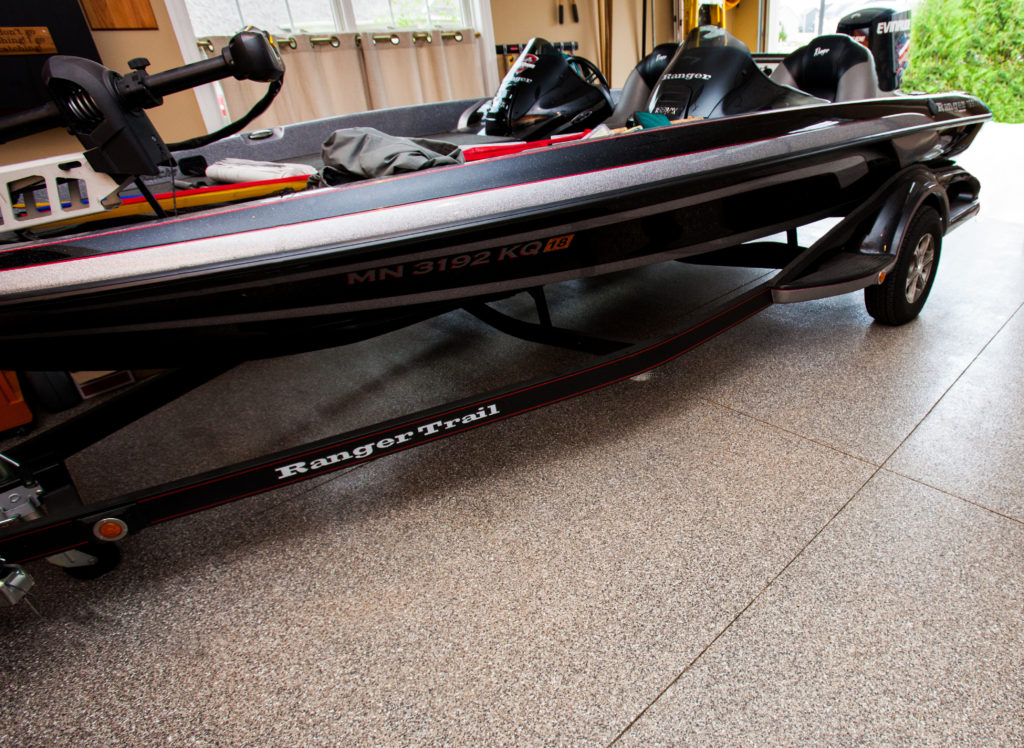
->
[864, 207, 942, 325]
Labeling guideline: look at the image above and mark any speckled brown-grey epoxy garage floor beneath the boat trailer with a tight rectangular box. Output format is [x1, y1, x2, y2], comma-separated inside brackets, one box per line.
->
[0, 125, 1024, 746]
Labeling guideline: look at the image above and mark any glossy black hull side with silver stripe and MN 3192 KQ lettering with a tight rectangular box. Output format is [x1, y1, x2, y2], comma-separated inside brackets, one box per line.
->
[0, 96, 987, 369]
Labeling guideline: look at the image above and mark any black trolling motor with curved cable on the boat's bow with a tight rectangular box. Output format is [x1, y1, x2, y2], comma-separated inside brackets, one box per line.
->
[0, 30, 285, 182]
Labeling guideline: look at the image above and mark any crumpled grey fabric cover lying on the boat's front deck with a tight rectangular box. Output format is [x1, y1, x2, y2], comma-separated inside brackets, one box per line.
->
[313, 127, 464, 184]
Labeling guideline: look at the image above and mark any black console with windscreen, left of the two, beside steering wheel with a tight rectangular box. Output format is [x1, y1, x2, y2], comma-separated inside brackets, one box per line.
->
[483, 39, 611, 140]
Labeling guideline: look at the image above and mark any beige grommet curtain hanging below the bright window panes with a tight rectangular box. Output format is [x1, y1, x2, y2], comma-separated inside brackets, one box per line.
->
[207, 29, 493, 129]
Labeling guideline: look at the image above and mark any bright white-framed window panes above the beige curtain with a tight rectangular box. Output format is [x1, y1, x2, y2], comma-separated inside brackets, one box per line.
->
[184, 0, 473, 37]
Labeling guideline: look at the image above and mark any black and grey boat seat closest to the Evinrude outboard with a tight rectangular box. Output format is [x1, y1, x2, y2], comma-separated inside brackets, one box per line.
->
[771, 34, 882, 101]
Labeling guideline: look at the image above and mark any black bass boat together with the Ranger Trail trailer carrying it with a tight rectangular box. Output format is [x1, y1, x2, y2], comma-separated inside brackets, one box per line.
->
[0, 21, 990, 604]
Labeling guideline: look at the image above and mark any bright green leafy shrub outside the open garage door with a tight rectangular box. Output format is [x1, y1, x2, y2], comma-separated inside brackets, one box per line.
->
[901, 0, 1024, 122]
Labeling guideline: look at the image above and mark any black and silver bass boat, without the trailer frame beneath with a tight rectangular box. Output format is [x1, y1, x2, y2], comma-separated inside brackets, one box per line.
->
[0, 27, 990, 370]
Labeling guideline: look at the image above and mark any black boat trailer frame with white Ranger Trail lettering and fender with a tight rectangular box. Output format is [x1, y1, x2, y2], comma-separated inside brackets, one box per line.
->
[0, 166, 979, 606]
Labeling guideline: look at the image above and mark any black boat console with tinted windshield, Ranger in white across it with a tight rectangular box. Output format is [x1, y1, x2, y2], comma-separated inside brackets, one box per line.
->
[648, 26, 822, 120]
